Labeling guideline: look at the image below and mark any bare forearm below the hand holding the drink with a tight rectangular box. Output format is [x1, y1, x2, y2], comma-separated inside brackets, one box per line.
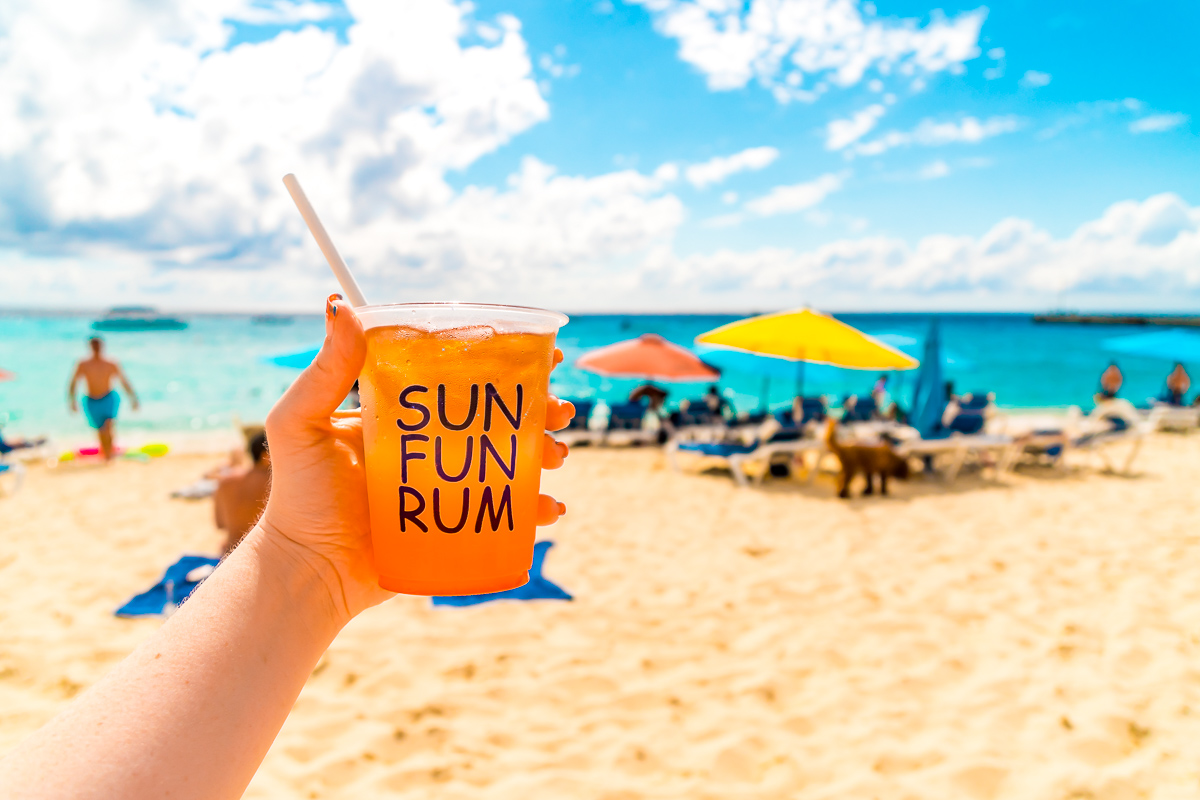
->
[0, 528, 344, 799]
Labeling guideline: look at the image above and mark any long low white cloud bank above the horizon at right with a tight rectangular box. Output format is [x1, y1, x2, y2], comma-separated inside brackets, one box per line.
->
[644, 194, 1200, 307]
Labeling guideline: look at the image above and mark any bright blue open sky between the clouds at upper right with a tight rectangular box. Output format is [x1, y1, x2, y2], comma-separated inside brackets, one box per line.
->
[465, 0, 1200, 249]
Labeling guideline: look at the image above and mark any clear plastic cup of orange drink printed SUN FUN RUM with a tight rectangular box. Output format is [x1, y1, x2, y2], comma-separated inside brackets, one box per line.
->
[358, 303, 566, 595]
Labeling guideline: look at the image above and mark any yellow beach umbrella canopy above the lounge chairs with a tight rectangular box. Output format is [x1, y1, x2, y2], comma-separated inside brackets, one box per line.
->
[696, 308, 920, 393]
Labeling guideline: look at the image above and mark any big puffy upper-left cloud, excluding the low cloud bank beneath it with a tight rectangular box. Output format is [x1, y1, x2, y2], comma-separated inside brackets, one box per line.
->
[0, 0, 548, 269]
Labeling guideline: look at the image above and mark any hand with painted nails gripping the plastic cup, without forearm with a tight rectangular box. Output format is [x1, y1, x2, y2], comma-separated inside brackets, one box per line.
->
[252, 295, 575, 624]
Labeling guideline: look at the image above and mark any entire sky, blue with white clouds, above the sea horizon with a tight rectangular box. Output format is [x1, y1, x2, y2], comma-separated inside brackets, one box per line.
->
[0, 0, 1200, 311]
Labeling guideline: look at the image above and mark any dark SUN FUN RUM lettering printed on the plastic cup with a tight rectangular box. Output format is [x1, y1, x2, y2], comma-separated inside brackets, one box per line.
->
[396, 384, 524, 534]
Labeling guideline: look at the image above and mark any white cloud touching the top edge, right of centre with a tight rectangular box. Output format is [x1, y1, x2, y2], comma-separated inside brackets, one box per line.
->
[632, 0, 986, 102]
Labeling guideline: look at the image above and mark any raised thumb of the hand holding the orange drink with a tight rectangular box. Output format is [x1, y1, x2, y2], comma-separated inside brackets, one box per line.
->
[266, 295, 367, 435]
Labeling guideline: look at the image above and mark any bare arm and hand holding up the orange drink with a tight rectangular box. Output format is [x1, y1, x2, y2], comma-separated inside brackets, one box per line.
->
[0, 295, 575, 800]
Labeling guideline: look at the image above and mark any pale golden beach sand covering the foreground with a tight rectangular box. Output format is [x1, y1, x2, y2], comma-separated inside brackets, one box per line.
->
[0, 435, 1200, 800]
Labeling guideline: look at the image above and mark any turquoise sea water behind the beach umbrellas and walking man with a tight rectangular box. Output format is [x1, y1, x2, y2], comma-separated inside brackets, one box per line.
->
[0, 312, 1185, 438]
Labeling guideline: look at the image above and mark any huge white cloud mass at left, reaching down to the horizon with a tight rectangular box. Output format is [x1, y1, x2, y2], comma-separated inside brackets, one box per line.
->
[0, 0, 696, 308]
